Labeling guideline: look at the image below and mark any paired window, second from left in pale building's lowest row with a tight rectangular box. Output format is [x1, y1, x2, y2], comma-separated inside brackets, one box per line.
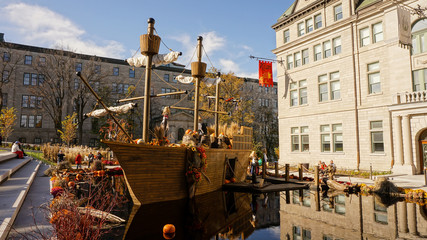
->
[320, 124, 344, 152]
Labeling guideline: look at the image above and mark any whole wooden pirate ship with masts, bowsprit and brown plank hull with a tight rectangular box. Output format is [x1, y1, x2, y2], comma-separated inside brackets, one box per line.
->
[78, 18, 252, 204]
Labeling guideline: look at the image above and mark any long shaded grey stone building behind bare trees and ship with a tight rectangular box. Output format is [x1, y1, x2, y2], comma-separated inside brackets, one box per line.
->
[0, 34, 277, 146]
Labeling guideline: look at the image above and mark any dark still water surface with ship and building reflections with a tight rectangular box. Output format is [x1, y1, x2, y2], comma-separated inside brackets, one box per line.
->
[114, 190, 427, 240]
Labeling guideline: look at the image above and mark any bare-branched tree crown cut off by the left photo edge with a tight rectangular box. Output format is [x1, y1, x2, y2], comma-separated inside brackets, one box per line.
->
[0, 41, 23, 110]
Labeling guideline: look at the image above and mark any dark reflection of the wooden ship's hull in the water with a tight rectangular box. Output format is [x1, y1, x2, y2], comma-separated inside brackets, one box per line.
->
[125, 191, 254, 240]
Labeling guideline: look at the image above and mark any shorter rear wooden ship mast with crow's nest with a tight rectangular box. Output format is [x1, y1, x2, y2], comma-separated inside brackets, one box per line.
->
[191, 36, 206, 131]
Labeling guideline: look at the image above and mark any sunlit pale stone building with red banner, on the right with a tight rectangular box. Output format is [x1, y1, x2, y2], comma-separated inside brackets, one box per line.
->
[272, 0, 427, 174]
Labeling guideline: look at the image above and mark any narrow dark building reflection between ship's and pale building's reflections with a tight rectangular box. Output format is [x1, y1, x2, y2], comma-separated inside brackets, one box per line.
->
[256, 192, 280, 228]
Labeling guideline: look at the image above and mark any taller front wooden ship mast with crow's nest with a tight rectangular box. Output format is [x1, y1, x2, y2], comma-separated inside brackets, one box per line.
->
[140, 18, 161, 143]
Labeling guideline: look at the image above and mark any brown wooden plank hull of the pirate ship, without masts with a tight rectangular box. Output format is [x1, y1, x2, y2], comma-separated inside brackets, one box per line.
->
[105, 142, 251, 204]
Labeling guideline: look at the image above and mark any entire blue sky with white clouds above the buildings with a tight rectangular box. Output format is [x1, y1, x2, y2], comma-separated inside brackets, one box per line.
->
[0, 0, 293, 78]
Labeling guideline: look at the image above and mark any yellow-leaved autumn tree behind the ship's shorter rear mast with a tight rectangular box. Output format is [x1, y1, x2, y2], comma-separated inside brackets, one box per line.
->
[199, 68, 254, 125]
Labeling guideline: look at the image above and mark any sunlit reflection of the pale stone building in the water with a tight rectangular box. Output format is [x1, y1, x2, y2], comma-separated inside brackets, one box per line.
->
[280, 190, 427, 240]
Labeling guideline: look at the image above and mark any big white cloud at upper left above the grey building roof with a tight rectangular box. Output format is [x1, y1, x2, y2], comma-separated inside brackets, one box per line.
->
[0, 3, 124, 58]
